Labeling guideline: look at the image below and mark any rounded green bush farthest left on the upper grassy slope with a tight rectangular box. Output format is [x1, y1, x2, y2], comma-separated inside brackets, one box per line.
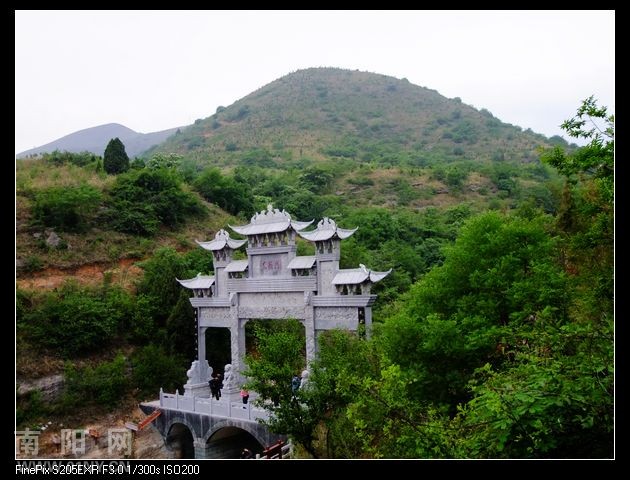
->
[32, 185, 101, 232]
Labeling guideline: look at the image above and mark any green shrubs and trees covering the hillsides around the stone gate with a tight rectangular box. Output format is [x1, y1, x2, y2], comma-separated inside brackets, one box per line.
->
[16, 72, 614, 458]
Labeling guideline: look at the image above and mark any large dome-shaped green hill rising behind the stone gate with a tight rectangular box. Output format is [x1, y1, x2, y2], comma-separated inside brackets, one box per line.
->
[152, 68, 564, 166]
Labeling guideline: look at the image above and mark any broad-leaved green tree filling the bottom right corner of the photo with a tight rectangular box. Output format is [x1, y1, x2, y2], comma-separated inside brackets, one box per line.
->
[456, 319, 614, 458]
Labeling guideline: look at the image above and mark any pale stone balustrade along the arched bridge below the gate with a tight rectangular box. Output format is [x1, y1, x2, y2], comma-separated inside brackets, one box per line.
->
[160, 388, 269, 421]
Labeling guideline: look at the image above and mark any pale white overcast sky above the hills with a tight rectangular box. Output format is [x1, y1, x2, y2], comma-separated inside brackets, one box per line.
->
[15, 11, 615, 153]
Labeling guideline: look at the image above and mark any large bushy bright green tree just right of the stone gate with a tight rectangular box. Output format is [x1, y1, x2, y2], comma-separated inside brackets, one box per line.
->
[383, 212, 567, 409]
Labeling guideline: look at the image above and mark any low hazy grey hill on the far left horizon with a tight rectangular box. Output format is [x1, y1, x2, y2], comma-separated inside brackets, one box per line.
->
[17, 123, 177, 158]
